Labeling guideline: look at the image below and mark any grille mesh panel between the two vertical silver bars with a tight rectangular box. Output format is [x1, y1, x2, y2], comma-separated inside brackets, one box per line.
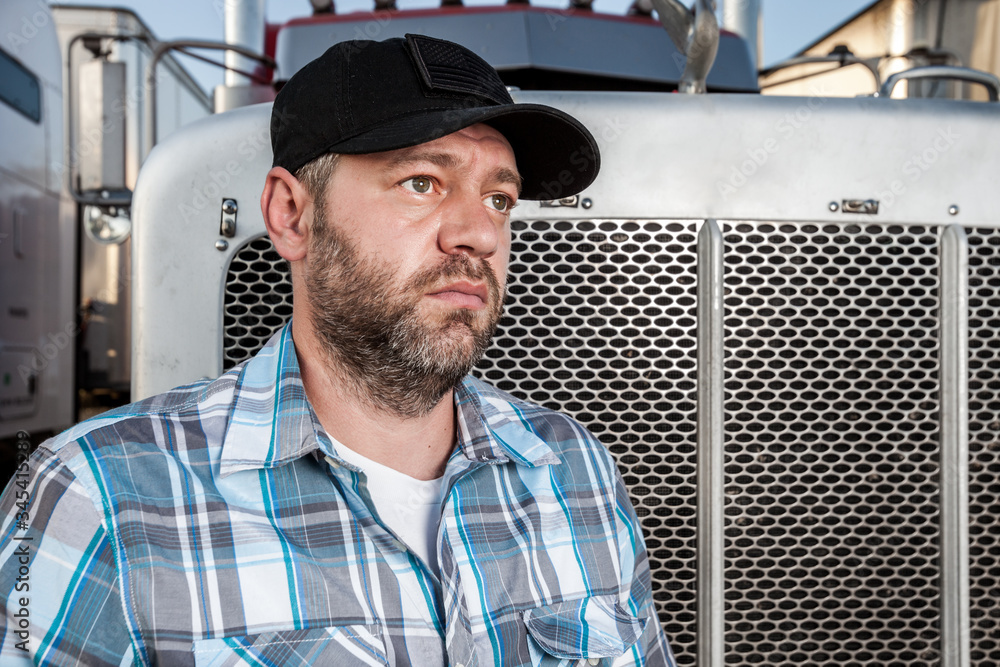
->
[724, 223, 939, 667]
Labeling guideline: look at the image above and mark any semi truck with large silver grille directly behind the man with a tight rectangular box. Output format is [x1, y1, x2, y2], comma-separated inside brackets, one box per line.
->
[0, 0, 1000, 667]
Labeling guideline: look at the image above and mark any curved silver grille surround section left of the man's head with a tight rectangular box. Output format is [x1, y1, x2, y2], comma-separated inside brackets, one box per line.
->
[132, 104, 271, 398]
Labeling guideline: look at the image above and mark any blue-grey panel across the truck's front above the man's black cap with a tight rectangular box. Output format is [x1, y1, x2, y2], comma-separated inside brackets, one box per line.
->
[276, 6, 757, 91]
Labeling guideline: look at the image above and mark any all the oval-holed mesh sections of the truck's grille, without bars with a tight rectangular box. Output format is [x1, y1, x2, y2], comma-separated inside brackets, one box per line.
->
[223, 220, 1000, 667]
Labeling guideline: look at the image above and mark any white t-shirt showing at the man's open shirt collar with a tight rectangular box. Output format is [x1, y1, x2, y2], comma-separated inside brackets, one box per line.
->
[327, 442, 444, 572]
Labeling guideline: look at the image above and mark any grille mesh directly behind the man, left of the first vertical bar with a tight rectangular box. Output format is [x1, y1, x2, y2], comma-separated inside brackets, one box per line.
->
[221, 220, 708, 664]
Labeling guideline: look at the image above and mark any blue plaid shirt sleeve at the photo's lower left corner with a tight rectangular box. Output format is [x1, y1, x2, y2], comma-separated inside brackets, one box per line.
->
[0, 446, 132, 666]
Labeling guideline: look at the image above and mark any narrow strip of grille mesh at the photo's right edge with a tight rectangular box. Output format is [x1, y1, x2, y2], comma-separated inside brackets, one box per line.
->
[966, 229, 1000, 665]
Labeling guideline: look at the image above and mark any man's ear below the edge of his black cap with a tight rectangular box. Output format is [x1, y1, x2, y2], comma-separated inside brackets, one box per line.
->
[260, 167, 313, 262]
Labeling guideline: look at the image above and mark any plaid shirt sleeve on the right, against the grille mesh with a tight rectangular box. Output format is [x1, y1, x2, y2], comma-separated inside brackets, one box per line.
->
[614, 464, 676, 667]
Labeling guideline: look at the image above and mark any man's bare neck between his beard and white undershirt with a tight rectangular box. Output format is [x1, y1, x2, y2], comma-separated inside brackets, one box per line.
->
[292, 318, 455, 480]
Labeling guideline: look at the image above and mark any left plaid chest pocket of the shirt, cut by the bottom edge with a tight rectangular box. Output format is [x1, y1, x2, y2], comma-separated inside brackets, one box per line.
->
[192, 625, 389, 667]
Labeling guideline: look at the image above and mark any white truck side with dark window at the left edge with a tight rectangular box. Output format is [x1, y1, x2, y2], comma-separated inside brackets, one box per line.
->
[0, 0, 79, 444]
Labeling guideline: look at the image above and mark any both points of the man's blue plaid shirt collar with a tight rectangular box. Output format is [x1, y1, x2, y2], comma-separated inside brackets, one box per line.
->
[219, 323, 559, 476]
